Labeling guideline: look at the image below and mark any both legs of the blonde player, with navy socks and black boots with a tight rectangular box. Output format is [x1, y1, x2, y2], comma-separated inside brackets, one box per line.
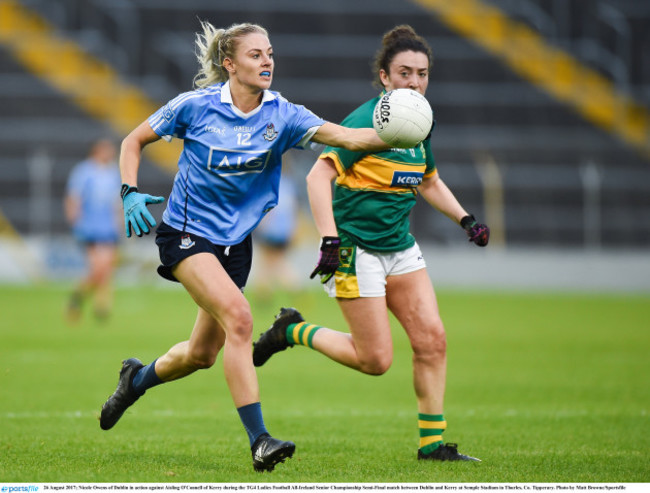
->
[100, 253, 295, 471]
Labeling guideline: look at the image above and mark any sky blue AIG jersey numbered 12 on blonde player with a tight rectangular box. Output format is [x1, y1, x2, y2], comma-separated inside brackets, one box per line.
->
[148, 82, 325, 245]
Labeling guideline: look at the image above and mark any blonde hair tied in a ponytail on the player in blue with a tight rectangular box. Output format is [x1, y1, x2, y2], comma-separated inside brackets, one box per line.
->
[194, 21, 269, 89]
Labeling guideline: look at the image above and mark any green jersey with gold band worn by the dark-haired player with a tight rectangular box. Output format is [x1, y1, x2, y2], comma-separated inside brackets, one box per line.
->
[320, 96, 437, 252]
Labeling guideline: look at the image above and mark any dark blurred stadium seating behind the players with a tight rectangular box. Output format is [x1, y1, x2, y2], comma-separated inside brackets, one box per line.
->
[0, 0, 650, 247]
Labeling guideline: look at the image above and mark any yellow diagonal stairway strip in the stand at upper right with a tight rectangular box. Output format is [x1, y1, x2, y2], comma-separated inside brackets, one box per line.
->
[414, 0, 650, 158]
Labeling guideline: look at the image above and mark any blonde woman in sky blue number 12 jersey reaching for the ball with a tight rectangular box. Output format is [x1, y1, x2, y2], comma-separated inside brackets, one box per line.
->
[100, 22, 388, 471]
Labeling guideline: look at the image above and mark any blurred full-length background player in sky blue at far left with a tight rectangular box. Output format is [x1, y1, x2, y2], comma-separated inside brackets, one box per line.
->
[64, 139, 121, 323]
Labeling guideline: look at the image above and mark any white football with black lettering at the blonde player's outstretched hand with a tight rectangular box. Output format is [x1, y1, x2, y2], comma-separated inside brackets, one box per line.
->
[372, 89, 433, 149]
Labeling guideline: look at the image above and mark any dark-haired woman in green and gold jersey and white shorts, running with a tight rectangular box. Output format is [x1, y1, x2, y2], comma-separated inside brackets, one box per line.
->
[253, 26, 489, 461]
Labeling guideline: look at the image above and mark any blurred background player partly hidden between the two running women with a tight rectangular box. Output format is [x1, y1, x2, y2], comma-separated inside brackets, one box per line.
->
[254, 155, 298, 298]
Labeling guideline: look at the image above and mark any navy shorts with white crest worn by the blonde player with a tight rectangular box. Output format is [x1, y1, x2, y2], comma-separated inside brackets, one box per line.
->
[156, 223, 253, 289]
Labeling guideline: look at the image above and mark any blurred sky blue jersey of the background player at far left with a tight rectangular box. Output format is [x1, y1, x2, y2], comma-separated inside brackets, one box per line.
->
[67, 159, 122, 243]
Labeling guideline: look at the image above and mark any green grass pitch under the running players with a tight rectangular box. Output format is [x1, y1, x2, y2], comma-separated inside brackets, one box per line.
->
[0, 285, 650, 483]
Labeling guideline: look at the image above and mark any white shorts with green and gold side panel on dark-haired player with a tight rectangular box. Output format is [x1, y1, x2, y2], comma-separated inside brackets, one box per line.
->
[323, 243, 426, 298]
